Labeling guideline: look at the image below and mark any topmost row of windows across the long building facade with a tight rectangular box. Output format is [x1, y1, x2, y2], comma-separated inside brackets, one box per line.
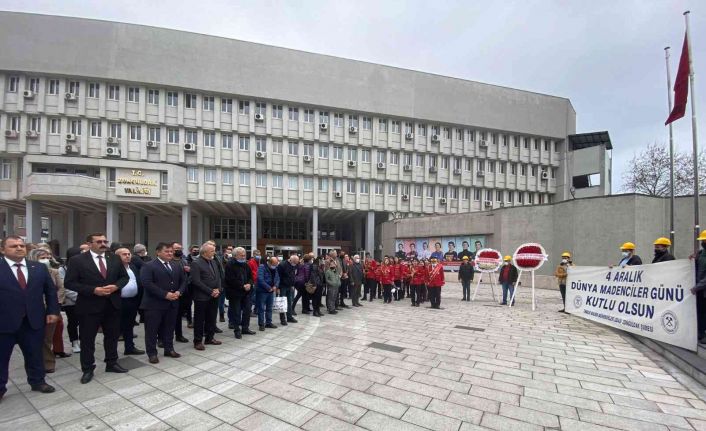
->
[7, 76, 558, 151]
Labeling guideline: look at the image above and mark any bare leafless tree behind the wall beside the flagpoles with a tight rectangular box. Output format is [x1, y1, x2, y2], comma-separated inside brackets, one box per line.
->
[621, 143, 706, 196]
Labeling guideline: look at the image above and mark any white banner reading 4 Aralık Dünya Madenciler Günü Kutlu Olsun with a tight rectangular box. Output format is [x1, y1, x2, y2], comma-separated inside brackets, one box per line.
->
[566, 259, 697, 351]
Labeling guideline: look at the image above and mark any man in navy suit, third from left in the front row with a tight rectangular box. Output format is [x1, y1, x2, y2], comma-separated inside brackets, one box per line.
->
[140, 242, 186, 364]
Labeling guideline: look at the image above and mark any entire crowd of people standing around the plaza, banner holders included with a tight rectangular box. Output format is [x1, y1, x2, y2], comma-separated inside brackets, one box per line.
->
[0, 231, 706, 400]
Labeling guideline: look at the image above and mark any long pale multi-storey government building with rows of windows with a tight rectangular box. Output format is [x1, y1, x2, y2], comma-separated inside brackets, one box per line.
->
[0, 12, 611, 254]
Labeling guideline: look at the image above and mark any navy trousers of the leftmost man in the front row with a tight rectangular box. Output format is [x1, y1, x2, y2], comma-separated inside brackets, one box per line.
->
[0, 316, 45, 393]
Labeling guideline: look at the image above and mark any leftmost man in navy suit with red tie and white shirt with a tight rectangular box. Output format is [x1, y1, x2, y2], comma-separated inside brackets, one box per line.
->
[0, 235, 60, 400]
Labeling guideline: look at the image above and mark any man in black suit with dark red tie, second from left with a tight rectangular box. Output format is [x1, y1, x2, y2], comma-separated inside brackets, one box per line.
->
[64, 233, 130, 384]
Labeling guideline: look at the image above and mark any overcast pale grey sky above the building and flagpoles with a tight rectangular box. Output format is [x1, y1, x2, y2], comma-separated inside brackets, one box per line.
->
[0, 0, 706, 192]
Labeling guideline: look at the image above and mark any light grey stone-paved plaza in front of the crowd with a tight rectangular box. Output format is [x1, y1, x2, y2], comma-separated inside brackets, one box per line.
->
[0, 283, 706, 431]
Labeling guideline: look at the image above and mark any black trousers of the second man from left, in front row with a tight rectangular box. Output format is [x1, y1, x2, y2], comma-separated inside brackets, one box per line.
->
[78, 300, 120, 372]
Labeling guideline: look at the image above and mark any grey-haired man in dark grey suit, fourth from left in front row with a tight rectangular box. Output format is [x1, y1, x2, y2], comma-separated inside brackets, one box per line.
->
[191, 242, 223, 350]
